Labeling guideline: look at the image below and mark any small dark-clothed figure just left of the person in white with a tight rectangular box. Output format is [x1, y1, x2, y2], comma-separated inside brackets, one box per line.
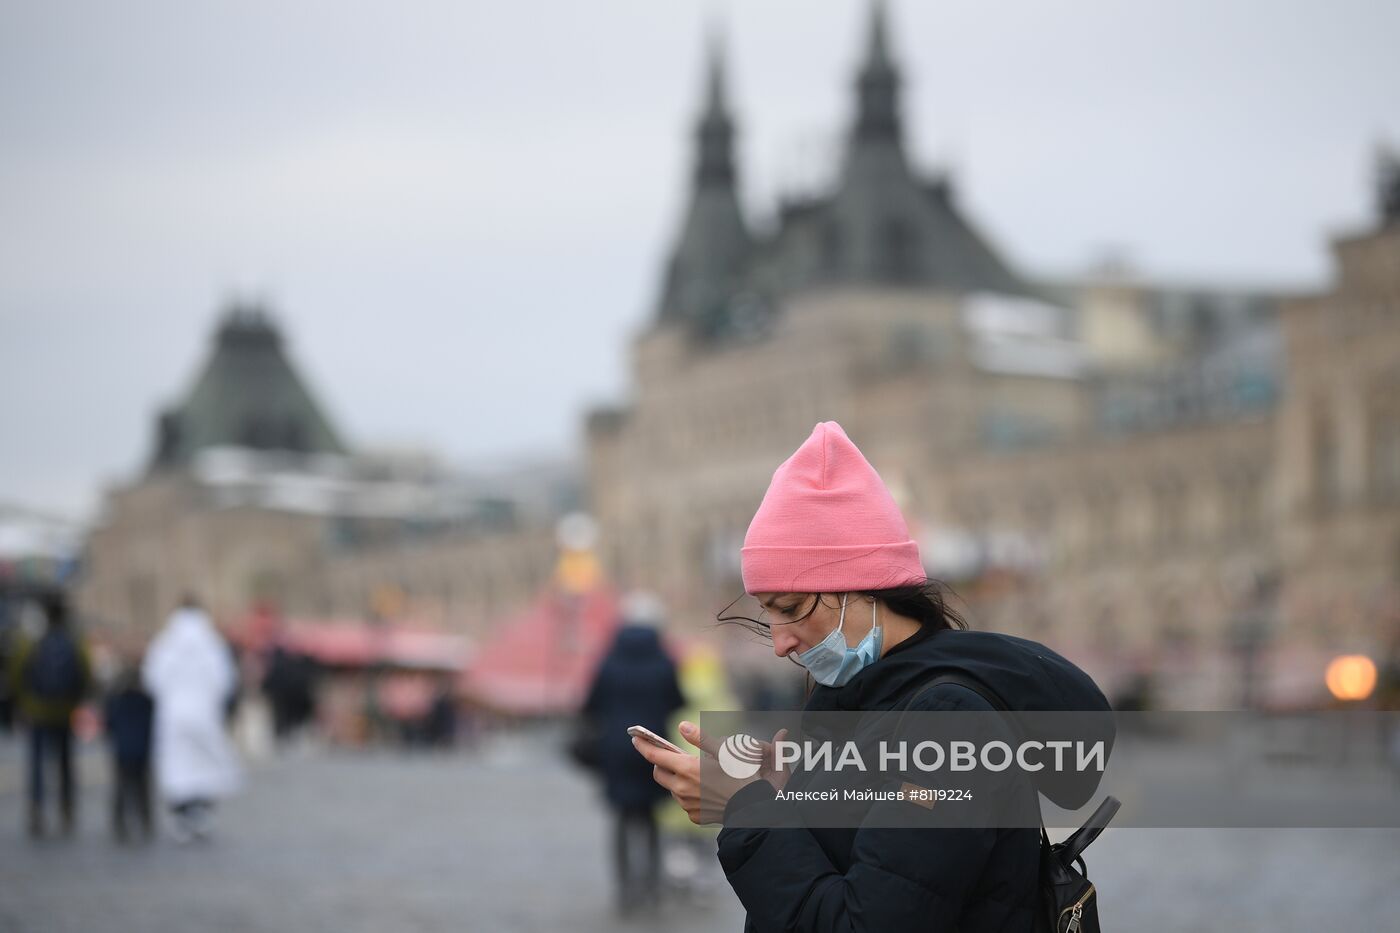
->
[102, 667, 155, 842]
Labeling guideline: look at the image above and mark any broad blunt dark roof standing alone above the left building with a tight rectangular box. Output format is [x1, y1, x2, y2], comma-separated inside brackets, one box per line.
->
[151, 304, 346, 469]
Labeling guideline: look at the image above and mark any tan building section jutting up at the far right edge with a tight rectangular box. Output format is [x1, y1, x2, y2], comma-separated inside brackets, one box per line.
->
[1275, 156, 1400, 650]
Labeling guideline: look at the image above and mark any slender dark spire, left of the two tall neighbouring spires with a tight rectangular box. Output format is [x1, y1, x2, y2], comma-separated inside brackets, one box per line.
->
[657, 35, 752, 326]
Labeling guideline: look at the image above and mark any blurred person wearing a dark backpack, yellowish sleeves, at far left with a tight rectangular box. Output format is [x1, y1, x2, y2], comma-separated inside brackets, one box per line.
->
[10, 590, 92, 836]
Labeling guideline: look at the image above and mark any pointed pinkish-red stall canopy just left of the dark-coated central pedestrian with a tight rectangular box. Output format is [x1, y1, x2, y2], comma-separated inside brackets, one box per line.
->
[461, 586, 619, 716]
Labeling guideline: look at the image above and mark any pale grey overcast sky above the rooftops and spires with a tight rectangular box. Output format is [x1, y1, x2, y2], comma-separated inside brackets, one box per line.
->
[8, 0, 1400, 516]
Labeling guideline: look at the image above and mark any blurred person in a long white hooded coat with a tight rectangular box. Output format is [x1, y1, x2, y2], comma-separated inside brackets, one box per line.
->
[141, 597, 242, 842]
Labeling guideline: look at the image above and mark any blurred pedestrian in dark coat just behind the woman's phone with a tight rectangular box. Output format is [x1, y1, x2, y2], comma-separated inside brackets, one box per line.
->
[582, 593, 685, 913]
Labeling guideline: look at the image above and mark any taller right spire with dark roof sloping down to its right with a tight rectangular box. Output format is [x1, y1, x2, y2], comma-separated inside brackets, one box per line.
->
[822, 0, 1025, 293]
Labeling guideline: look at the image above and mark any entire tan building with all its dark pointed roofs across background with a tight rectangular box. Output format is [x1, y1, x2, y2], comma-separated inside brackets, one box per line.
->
[68, 6, 1400, 703]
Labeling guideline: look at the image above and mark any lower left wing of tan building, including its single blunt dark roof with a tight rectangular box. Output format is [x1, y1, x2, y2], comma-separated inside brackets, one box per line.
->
[77, 307, 578, 639]
